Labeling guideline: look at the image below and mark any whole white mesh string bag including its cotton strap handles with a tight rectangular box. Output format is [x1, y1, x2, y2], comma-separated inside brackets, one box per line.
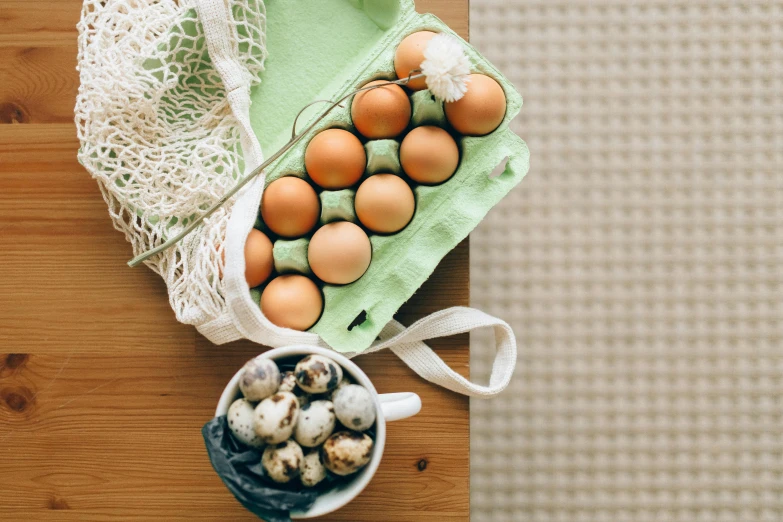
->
[75, 0, 516, 397]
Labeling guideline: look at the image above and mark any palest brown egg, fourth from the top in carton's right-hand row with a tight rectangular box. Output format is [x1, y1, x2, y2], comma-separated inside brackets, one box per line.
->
[307, 221, 372, 285]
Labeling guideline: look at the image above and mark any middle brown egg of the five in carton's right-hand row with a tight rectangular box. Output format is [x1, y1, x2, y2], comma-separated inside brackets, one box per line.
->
[354, 174, 416, 234]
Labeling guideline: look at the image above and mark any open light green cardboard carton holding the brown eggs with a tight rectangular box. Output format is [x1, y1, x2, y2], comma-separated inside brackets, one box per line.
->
[250, 0, 529, 352]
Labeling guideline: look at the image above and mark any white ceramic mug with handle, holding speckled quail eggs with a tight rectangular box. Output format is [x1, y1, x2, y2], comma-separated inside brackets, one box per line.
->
[215, 346, 421, 519]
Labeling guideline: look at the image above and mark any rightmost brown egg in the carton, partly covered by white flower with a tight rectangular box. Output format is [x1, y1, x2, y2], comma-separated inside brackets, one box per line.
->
[444, 74, 506, 136]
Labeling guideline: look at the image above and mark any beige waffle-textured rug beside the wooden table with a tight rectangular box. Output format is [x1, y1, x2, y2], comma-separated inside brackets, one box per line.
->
[471, 0, 783, 522]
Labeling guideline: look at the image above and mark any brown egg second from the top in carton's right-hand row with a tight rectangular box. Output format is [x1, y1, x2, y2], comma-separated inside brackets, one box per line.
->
[400, 126, 459, 185]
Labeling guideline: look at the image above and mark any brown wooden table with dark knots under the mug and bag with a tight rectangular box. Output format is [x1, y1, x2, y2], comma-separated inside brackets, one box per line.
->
[0, 0, 469, 521]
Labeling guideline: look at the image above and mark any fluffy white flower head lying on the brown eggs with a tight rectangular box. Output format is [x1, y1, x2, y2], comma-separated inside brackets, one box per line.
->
[421, 33, 470, 102]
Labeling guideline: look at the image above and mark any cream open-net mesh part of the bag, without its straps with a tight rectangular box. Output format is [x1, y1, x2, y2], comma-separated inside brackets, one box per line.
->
[74, 0, 266, 325]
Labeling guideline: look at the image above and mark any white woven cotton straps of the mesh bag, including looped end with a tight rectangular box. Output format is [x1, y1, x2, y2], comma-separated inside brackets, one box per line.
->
[196, 0, 517, 398]
